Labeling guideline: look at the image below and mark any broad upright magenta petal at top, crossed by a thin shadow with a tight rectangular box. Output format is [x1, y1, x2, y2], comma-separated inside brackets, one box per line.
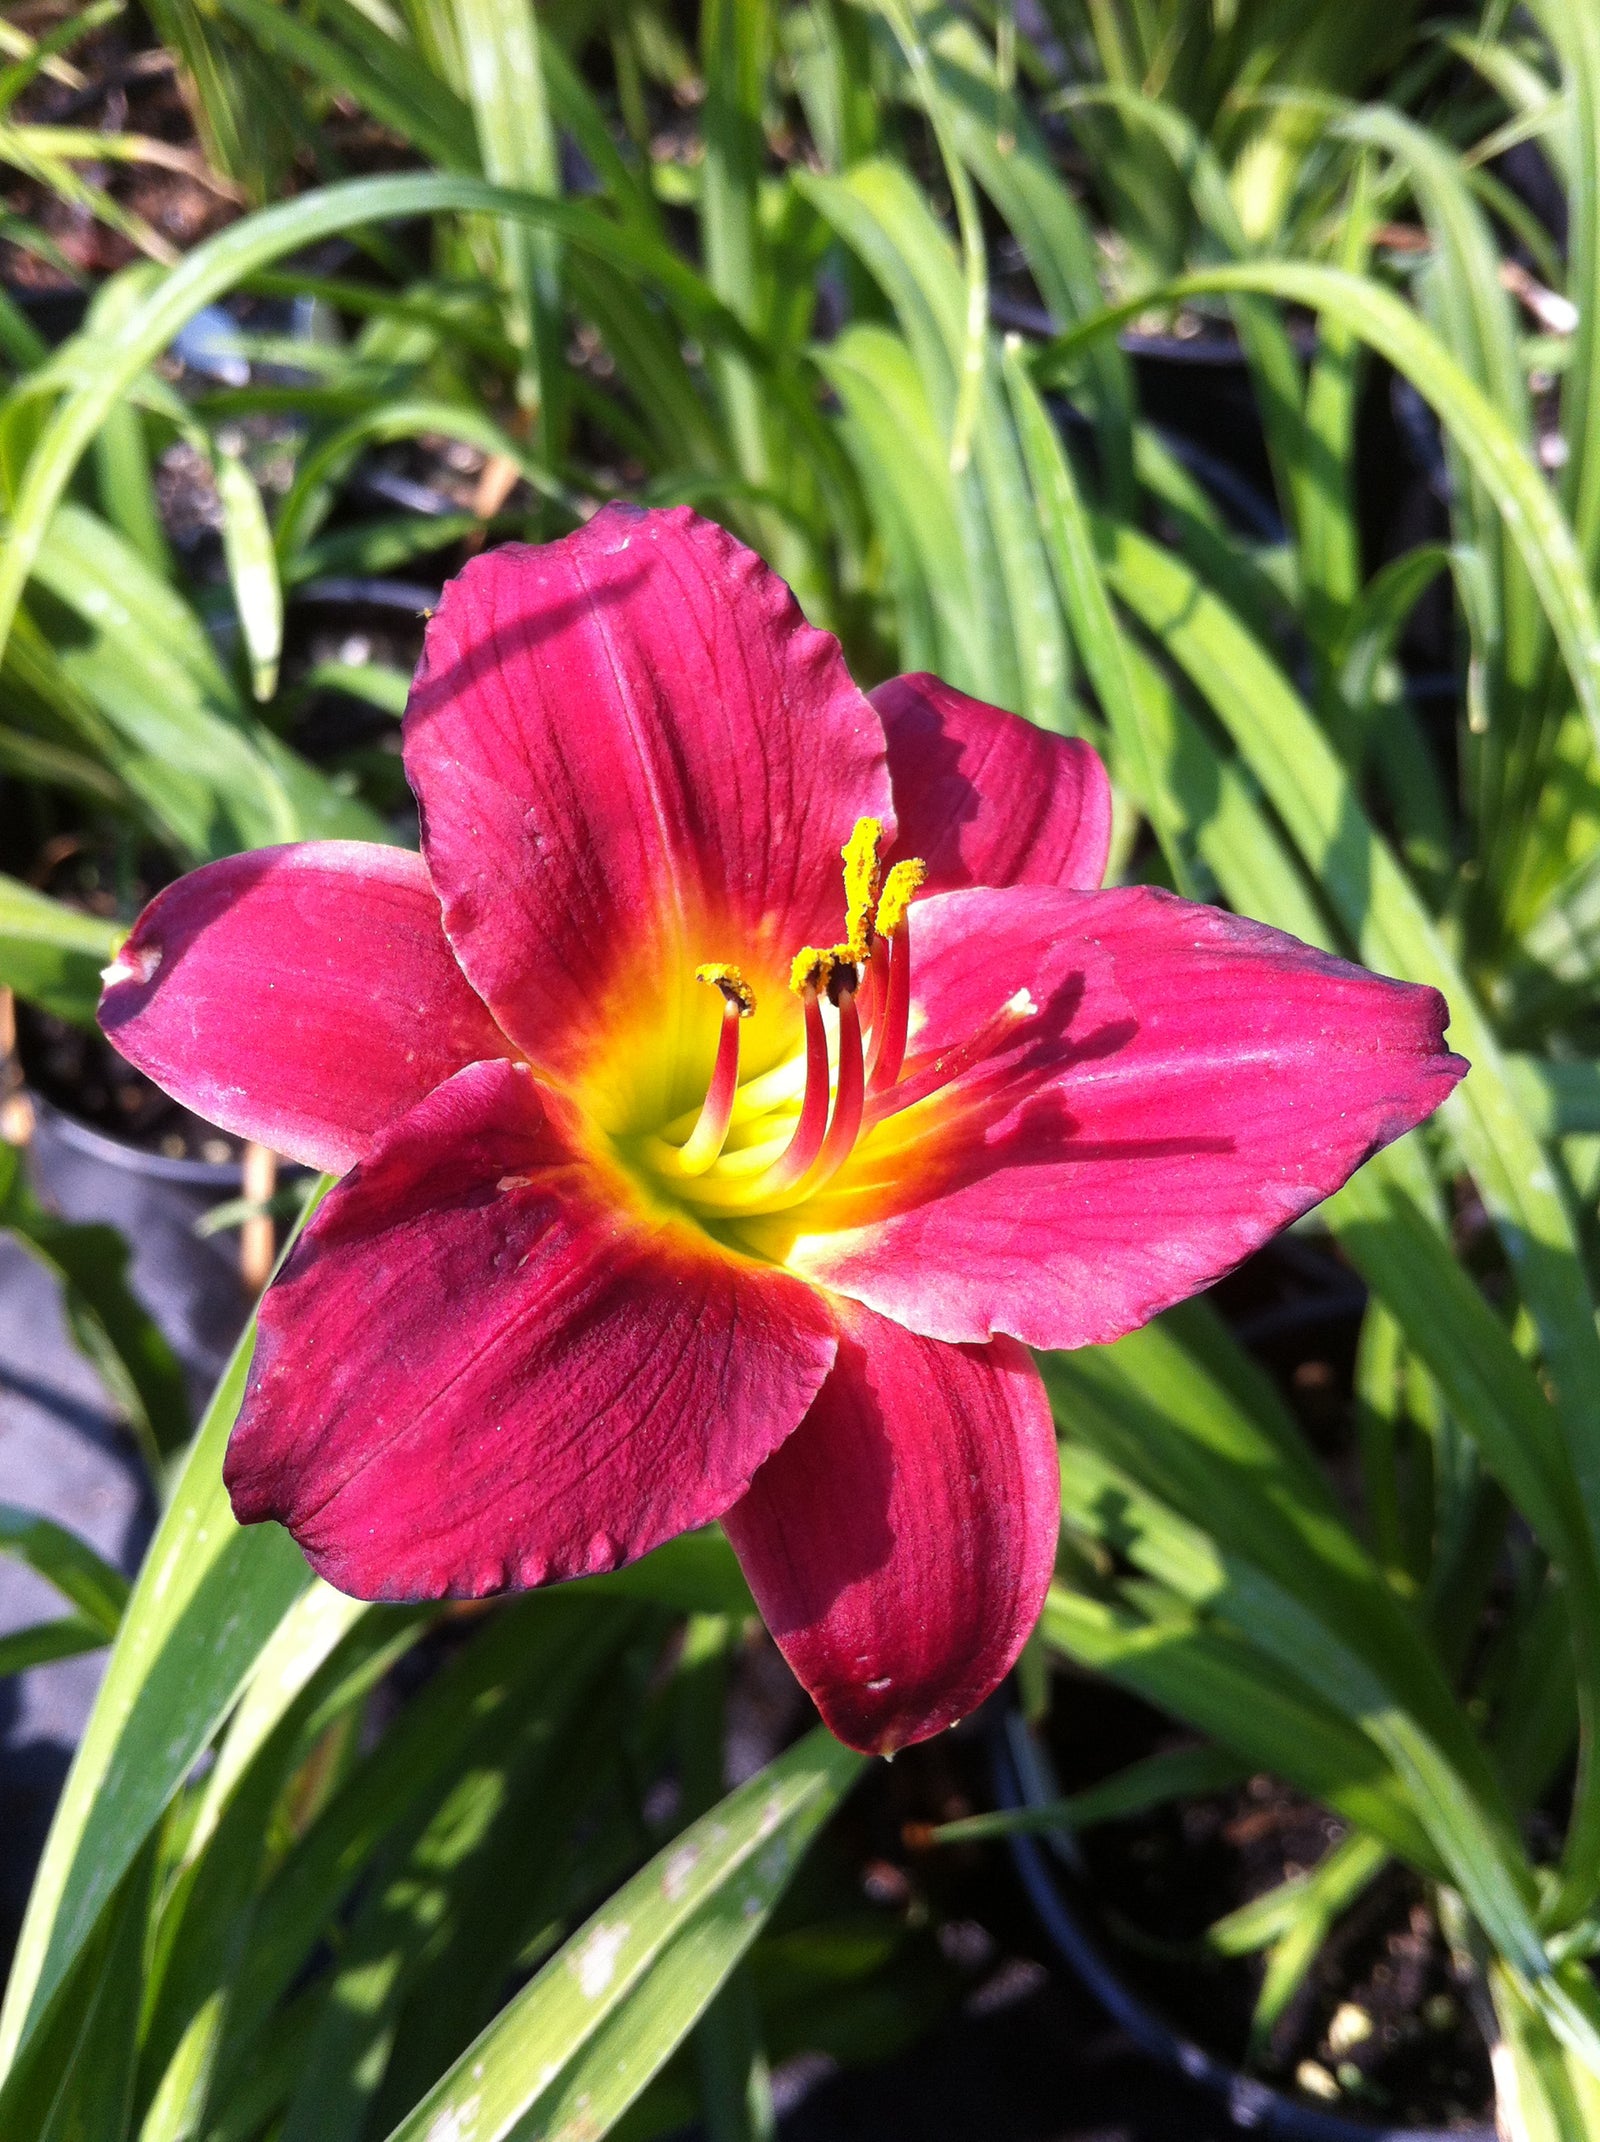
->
[405, 506, 893, 1071]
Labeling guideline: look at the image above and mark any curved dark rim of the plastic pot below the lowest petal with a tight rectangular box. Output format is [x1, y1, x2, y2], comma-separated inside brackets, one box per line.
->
[990, 1705, 1497, 2142]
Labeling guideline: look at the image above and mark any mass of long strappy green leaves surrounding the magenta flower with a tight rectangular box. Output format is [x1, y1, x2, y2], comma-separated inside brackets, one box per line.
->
[0, 0, 1600, 2142]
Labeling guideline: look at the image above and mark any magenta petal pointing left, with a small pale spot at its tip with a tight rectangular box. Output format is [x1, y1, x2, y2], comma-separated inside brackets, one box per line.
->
[101, 840, 510, 1172]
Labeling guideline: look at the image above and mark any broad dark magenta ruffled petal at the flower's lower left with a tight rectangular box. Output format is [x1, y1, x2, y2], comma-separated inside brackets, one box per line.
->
[225, 1062, 835, 1600]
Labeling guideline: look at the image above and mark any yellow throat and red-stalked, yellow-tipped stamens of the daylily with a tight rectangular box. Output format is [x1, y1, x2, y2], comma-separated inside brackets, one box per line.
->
[638, 818, 938, 1221]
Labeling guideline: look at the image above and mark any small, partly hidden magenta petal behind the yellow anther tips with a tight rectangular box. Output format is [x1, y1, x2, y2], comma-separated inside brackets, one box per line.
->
[872, 675, 1112, 893]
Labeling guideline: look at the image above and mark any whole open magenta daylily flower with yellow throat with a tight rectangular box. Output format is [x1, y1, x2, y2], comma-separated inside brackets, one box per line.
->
[101, 506, 1465, 1750]
